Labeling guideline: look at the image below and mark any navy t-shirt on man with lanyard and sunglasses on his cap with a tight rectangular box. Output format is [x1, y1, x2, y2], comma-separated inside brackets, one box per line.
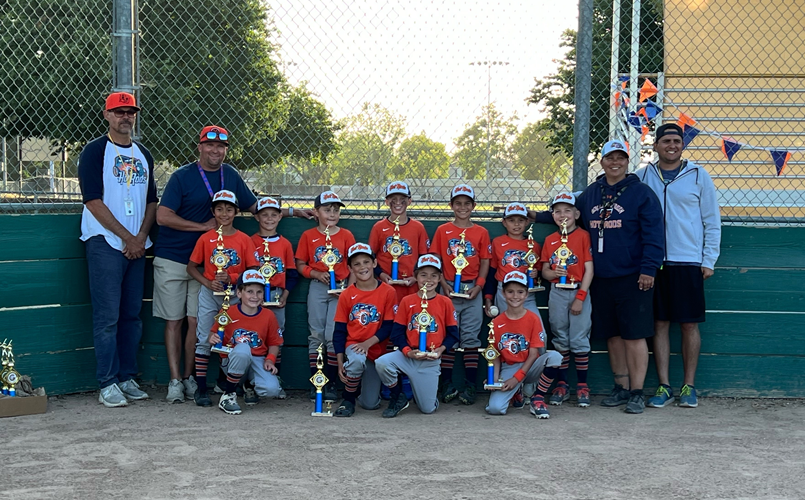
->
[154, 162, 257, 264]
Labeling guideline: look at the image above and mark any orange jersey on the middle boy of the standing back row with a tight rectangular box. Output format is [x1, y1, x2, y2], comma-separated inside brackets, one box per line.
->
[369, 218, 430, 301]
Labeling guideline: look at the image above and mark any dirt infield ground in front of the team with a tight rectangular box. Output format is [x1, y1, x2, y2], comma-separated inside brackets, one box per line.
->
[0, 389, 805, 500]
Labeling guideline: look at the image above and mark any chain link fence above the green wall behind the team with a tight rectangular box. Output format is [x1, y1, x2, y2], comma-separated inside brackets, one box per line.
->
[0, 0, 805, 223]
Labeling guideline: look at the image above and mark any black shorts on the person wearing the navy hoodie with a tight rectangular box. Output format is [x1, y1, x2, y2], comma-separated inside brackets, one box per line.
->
[590, 273, 654, 340]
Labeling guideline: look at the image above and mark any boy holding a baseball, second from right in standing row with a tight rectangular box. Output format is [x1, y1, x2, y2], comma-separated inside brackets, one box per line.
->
[484, 203, 540, 318]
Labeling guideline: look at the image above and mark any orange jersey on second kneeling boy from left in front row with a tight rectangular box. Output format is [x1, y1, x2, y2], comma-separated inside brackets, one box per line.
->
[335, 283, 397, 361]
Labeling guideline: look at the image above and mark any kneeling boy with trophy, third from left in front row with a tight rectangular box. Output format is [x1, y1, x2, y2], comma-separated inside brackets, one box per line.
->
[375, 254, 458, 418]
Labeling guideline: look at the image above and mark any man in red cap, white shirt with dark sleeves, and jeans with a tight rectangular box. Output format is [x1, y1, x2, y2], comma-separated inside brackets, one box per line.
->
[78, 92, 159, 407]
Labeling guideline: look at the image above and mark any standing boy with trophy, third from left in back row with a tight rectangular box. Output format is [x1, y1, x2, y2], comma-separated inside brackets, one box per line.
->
[296, 191, 355, 402]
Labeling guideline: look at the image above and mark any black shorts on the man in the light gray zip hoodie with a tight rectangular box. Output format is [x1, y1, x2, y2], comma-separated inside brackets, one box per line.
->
[654, 264, 705, 323]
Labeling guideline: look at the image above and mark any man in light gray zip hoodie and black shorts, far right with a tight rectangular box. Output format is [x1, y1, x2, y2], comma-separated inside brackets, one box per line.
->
[636, 124, 721, 408]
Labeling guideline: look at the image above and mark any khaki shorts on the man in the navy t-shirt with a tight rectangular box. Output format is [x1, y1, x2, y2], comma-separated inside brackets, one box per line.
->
[152, 257, 201, 321]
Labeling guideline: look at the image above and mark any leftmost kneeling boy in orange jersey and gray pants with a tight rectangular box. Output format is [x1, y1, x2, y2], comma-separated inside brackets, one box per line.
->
[208, 269, 282, 415]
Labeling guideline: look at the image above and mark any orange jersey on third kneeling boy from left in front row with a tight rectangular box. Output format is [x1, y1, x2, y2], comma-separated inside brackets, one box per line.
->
[394, 294, 458, 349]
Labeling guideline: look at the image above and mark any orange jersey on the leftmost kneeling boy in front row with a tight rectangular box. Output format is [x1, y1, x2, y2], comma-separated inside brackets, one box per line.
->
[210, 304, 283, 358]
